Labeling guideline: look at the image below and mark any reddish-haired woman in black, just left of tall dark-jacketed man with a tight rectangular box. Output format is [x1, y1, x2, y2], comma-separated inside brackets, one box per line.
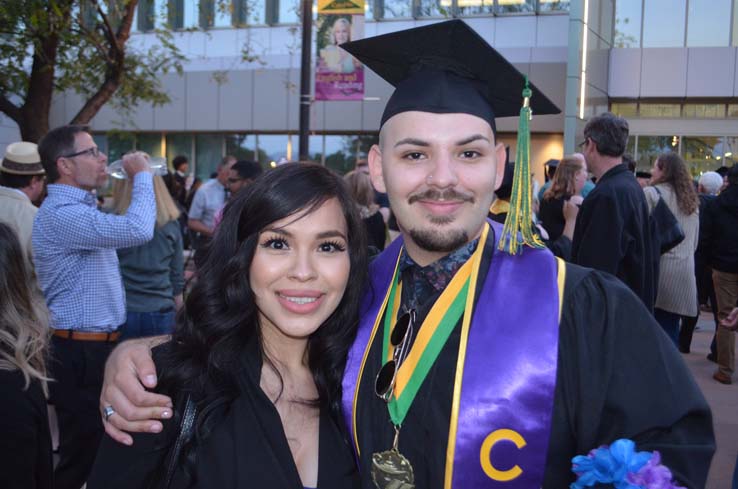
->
[538, 156, 587, 241]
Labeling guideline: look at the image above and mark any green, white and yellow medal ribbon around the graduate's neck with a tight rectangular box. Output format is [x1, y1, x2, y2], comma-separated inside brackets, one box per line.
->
[382, 225, 489, 426]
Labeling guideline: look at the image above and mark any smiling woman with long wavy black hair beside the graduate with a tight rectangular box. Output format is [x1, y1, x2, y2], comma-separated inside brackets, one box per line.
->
[88, 163, 367, 489]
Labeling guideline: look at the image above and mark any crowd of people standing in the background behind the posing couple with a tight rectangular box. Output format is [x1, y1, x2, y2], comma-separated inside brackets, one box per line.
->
[0, 113, 738, 489]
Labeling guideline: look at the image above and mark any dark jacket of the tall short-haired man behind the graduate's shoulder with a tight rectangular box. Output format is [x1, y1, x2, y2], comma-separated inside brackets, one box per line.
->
[571, 164, 660, 311]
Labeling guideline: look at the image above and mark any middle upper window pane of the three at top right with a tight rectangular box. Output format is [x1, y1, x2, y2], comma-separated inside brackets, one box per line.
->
[643, 0, 687, 48]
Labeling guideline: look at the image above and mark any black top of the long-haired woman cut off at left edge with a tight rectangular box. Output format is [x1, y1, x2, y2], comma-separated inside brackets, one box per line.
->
[0, 370, 54, 489]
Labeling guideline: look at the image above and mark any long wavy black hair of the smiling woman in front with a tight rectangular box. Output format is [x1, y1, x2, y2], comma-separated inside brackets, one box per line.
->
[159, 163, 367, 480]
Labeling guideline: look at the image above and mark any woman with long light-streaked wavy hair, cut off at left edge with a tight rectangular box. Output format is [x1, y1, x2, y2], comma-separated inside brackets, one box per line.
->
[0, 223, 54, 489]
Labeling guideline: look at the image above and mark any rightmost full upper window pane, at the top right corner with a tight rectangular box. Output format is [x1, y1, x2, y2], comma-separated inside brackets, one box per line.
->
[687, 0, 731, 47]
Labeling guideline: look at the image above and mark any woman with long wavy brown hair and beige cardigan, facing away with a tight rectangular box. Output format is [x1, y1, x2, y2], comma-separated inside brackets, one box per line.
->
[643, 153, 700, 346]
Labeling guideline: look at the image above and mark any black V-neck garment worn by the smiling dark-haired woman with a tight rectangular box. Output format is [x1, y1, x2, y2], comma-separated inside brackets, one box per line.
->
[87, 341, 360, 489]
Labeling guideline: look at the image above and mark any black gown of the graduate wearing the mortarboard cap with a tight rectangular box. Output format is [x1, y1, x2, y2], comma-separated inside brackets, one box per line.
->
[356, 230, 715, 489]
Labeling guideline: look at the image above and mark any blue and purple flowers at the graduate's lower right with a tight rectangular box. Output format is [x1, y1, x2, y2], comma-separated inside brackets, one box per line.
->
[569, 439, 684, 489]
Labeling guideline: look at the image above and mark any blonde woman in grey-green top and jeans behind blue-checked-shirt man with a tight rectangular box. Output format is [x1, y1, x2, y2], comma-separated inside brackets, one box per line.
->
[113, 175, 184, 339]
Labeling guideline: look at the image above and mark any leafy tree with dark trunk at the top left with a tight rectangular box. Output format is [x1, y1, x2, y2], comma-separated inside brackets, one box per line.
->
[0, 0, 185, 142]
